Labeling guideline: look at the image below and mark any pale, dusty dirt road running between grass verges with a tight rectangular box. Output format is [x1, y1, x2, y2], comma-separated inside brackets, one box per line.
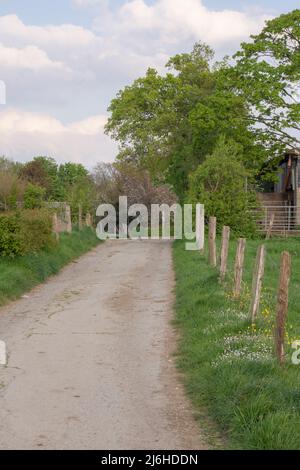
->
[0, 241, 205, 450]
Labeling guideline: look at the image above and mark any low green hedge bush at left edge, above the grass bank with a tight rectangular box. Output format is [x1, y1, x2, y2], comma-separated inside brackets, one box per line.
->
[0, 209, 54, 257]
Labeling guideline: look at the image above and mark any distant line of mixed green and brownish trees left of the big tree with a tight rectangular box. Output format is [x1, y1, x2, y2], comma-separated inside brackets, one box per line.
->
[0, 156, 176, 218]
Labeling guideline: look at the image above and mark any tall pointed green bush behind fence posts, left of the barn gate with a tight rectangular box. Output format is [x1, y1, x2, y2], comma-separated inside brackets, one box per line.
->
[188, 138, 258, 236]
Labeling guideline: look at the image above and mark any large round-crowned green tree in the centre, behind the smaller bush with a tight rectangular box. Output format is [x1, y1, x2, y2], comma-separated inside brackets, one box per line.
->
[106, 43, 259, 199]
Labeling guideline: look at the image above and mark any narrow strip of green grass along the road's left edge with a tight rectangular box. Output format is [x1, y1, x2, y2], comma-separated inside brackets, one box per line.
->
[0, 228, 99, 305]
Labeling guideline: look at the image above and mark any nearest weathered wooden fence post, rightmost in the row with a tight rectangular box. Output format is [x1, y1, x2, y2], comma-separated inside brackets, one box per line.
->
[275, 251, 291, 365]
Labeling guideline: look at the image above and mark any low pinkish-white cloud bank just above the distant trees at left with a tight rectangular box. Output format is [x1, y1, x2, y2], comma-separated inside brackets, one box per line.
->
[0, 109, 116, 168]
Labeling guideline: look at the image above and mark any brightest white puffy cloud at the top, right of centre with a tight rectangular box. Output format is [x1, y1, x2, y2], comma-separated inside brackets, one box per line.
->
[92, 0, 268, 46]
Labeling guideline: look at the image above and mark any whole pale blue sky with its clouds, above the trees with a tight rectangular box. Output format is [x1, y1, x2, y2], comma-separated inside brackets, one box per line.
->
[0, 0, 299, 167]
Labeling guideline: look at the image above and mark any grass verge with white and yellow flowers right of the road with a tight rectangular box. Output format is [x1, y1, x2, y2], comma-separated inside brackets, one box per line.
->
[174, 239, 300, 449]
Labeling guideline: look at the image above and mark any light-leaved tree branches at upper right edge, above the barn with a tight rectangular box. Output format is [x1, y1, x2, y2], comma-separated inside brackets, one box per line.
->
[229, 10, 300, 167]
